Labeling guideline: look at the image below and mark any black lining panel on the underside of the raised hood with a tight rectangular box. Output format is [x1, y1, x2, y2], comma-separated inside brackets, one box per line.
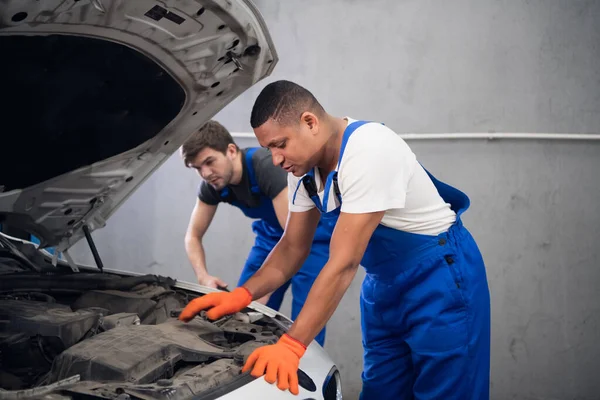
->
[0, 35, 185, 191]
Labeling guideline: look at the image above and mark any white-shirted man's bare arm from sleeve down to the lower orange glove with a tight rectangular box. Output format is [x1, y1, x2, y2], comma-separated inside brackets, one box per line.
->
[288, 211, 385, 346]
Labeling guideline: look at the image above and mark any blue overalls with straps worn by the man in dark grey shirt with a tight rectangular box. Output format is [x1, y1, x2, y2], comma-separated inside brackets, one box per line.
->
[219, 148, 332, 346]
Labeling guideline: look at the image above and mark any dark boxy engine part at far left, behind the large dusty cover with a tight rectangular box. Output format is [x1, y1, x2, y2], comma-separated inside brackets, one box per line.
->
[0, 300, 100, 348]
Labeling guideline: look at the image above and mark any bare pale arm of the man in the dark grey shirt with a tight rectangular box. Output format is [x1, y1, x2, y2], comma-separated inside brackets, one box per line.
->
[185, 199, 227, 288]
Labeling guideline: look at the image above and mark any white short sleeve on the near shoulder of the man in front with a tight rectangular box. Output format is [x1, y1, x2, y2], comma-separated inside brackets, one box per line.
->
[338, 123, 417, 214]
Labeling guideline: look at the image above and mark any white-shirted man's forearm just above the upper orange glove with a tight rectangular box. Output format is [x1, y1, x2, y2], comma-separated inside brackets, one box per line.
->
[244, 239, 310, 299]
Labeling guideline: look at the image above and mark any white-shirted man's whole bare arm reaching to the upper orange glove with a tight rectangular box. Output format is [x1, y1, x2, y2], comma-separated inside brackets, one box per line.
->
[243, 208, 321, 299]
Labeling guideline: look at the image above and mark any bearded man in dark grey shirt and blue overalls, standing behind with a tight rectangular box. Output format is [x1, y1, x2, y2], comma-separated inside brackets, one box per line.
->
[181, 121, 331, 345]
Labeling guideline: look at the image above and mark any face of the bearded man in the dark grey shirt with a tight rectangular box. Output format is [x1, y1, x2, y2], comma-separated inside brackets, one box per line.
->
[190, 145, 236, 190]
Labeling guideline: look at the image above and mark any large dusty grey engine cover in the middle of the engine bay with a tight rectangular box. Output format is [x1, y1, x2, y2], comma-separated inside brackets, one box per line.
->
[50, 318, 274, 384]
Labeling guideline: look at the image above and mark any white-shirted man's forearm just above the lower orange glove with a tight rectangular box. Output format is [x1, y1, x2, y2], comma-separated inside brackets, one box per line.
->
[288, 260, 358, 346]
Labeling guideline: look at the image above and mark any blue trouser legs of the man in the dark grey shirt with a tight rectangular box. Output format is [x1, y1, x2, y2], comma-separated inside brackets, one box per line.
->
[238, 236, 329, 346]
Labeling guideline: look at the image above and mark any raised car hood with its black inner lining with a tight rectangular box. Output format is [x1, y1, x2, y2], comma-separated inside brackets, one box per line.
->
[0, 0, 278, 251]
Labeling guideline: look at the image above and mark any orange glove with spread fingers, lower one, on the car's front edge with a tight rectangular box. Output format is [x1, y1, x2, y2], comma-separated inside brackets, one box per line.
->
[242, 333, 306, 395]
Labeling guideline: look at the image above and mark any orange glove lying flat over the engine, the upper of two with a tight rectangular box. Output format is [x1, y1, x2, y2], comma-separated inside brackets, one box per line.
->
[179, 286, 252, 322]
